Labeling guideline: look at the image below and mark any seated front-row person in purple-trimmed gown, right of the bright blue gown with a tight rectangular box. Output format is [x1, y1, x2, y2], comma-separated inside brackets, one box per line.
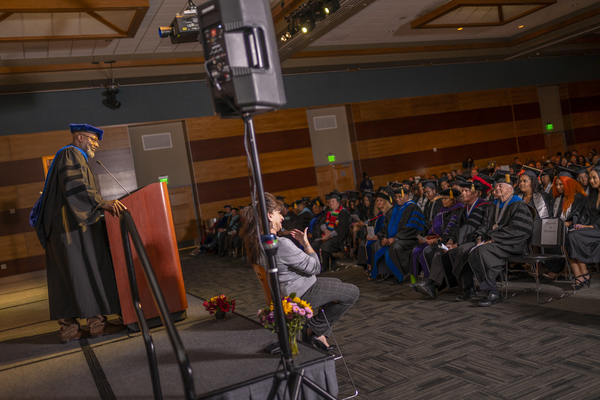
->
[411, 189, 465, 288]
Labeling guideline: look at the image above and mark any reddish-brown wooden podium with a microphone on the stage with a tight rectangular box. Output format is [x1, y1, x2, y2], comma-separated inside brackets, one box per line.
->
[105, 182, 188, 330]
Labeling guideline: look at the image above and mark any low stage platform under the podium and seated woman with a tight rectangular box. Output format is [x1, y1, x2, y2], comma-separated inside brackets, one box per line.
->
[0, 271, 338, 400]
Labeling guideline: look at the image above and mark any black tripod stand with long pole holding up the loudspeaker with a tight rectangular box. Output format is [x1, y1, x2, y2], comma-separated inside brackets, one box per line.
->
[242, 113, 335, 400]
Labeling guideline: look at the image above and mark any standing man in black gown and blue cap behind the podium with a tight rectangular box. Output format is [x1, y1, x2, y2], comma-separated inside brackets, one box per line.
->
[30, 124, 126, 342]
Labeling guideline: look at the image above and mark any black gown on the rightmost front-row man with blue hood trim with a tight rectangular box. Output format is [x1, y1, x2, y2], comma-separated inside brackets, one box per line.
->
[468, 196, 533, 292]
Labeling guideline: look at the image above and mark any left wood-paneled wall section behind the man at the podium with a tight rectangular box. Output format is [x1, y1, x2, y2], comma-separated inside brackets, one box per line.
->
[0, 126, 133, 277]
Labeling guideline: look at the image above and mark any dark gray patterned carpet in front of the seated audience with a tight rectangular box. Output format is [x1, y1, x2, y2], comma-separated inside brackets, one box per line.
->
[181, 250, 600, 400]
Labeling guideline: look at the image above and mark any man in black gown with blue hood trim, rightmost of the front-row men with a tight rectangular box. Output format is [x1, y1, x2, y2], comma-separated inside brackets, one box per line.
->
[468, 170, 535, 307]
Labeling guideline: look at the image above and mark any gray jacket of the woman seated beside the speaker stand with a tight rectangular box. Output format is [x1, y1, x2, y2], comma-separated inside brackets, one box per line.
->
[270, 237, 321, 297]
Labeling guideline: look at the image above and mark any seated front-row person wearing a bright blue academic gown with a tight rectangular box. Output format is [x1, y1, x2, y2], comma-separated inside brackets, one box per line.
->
[371, 186, 425, 283]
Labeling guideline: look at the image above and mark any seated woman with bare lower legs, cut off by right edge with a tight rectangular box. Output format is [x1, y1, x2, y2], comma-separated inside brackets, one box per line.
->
[566, 162, 600, 290]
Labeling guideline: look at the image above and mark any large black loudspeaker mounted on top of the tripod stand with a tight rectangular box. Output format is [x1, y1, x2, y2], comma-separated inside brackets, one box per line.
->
[197, 0, 286, 118]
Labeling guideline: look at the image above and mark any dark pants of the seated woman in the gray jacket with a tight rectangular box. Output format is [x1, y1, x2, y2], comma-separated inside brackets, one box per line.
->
[300, 278, 360, 336]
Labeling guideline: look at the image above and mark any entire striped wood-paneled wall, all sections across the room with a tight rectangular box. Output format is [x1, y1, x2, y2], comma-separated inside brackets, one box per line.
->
[0, 82, 600, 277]
